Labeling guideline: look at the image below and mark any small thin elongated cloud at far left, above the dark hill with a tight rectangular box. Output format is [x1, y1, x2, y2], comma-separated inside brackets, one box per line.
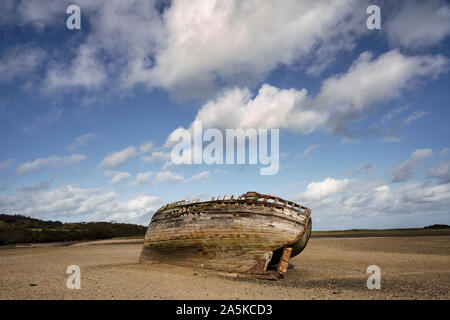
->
[16, 154, 87, 175]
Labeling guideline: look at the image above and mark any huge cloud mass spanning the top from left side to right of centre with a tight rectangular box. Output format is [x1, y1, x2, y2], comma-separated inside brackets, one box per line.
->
[10, 0, 367, 97]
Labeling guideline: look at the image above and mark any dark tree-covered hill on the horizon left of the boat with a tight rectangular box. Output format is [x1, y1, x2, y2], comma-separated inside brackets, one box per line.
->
[0, 214, 147, 245]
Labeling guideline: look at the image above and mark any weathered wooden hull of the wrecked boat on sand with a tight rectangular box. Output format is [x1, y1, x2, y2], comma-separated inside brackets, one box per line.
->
[140, 192, 311, 280]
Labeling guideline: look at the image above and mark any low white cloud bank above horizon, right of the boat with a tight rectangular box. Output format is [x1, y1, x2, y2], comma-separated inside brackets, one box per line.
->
[294, 178, 450, 223]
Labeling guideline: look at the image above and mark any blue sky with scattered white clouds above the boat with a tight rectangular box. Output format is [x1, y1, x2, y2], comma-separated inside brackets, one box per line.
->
[0, 0, 450, 230]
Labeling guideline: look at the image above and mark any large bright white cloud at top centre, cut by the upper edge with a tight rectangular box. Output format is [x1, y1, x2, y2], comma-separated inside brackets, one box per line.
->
[146, 0, 367, 95]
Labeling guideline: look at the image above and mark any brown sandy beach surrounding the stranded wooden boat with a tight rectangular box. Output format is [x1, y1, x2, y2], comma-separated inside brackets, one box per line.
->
[0, 236, 450, 299]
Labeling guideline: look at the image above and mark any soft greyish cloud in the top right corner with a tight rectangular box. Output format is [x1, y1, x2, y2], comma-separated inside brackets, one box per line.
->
[386, 0, 450, 49]
